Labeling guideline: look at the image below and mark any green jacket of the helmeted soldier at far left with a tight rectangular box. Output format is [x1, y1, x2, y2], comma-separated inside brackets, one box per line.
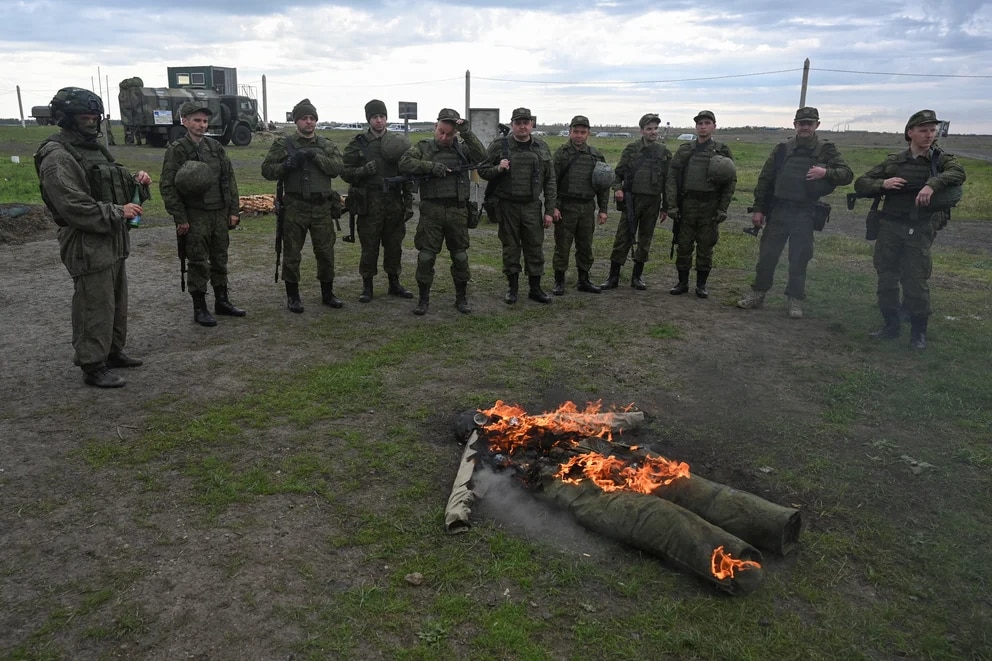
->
[39, 131, 131, 277]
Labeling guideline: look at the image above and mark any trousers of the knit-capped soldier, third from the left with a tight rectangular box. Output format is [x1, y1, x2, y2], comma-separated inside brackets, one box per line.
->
[282, 195, 337, 282]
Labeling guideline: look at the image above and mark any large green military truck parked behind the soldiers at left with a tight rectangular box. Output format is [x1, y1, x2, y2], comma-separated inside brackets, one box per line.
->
[117, 78, 263, 147]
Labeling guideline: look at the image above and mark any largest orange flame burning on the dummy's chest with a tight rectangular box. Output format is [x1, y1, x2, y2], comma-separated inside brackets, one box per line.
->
[482, 400, 631, 453]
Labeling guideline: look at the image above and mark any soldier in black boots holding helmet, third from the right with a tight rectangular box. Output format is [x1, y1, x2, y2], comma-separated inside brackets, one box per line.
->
[666, 110, 737, 298]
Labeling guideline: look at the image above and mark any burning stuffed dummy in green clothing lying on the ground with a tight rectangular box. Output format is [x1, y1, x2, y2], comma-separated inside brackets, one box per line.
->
[446, 401, 800, 593]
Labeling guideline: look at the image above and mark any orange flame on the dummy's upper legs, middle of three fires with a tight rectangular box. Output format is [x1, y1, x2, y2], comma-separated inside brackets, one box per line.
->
[555, 452, 689, 493]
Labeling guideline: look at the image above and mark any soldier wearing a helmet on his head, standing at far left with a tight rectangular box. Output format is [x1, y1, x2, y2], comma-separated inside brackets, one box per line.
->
[35, 87, 151, 388]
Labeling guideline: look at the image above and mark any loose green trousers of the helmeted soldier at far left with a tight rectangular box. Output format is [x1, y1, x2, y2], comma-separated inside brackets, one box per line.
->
[72, 259, 127, 367]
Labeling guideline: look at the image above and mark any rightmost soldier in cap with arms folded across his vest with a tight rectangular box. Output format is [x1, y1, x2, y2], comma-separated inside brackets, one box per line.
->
[854, 110, 965, 350]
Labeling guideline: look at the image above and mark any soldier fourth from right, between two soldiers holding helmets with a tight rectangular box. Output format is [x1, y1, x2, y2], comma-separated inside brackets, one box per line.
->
[600, 112, 672, 290]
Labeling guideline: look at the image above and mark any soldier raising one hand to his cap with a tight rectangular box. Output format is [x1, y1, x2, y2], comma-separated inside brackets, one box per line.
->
[399, 108, 486, 315]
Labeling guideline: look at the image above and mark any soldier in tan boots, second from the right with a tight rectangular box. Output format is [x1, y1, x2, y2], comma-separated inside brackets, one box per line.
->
[737, 107, 854, 319]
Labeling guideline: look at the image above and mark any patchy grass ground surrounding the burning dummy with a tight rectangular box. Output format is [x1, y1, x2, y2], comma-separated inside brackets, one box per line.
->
[0, 128, 992, 661]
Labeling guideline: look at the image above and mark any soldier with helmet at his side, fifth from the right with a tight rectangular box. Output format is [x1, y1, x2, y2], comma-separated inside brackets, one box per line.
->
[551, 115, 613, 296]
